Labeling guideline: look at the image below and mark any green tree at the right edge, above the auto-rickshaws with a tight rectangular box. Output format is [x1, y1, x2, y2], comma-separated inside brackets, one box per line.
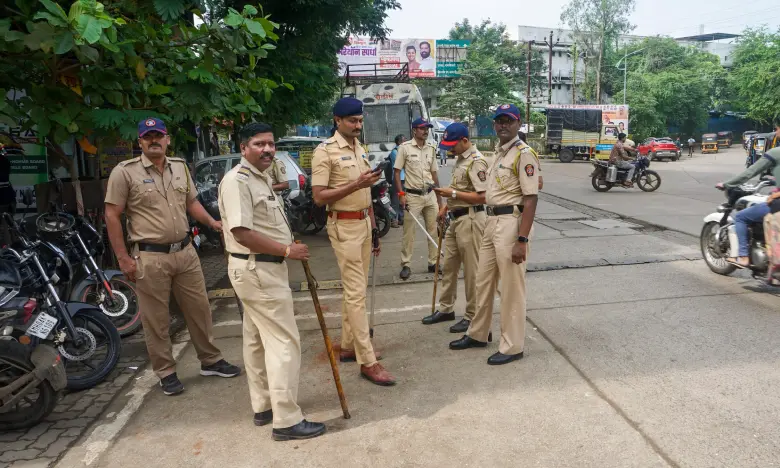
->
[729, 28, 780, 123]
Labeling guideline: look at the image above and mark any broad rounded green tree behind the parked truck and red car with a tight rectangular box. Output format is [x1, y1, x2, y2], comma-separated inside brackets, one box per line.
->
[609, 37, 726, 139]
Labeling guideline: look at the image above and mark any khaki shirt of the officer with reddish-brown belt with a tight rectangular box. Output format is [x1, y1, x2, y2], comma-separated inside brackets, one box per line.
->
[311, 132, 371, 211]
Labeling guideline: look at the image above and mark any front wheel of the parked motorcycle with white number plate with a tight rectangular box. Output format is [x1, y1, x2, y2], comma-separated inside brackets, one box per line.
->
[57, 309, 122, 390]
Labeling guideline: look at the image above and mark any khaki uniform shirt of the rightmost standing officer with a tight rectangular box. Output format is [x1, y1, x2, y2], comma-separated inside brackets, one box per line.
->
[485, 138, 539, 206]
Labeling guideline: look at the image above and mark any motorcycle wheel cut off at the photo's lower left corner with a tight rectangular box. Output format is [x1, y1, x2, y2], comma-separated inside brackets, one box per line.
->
[0, 340, 57, 432]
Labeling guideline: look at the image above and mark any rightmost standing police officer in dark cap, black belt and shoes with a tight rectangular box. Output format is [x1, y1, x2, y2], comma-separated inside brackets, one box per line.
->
[450, 104, 539, 365]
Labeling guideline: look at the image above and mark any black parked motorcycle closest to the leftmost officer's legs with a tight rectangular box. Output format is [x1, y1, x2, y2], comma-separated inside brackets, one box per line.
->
[34, 212, 141, 336]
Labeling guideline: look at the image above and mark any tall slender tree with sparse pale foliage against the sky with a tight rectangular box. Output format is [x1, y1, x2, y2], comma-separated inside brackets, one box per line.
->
[561, 0, 635, 104]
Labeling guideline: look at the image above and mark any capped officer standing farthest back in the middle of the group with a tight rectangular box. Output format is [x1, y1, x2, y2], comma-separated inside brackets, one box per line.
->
[394, 118, 441, 279]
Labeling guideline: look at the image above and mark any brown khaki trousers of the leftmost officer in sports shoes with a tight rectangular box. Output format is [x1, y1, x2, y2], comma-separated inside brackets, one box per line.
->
[136, 244, 222, 379]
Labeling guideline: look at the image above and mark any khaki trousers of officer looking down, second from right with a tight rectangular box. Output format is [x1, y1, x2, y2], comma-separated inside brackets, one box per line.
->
[439, 208, 487, 321]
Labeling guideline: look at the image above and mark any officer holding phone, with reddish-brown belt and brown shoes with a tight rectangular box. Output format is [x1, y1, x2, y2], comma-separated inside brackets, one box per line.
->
[311, 98, 395, 385]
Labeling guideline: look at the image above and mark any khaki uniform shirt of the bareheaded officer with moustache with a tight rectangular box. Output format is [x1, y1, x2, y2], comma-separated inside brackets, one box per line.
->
[219, 158, 293, 254]
